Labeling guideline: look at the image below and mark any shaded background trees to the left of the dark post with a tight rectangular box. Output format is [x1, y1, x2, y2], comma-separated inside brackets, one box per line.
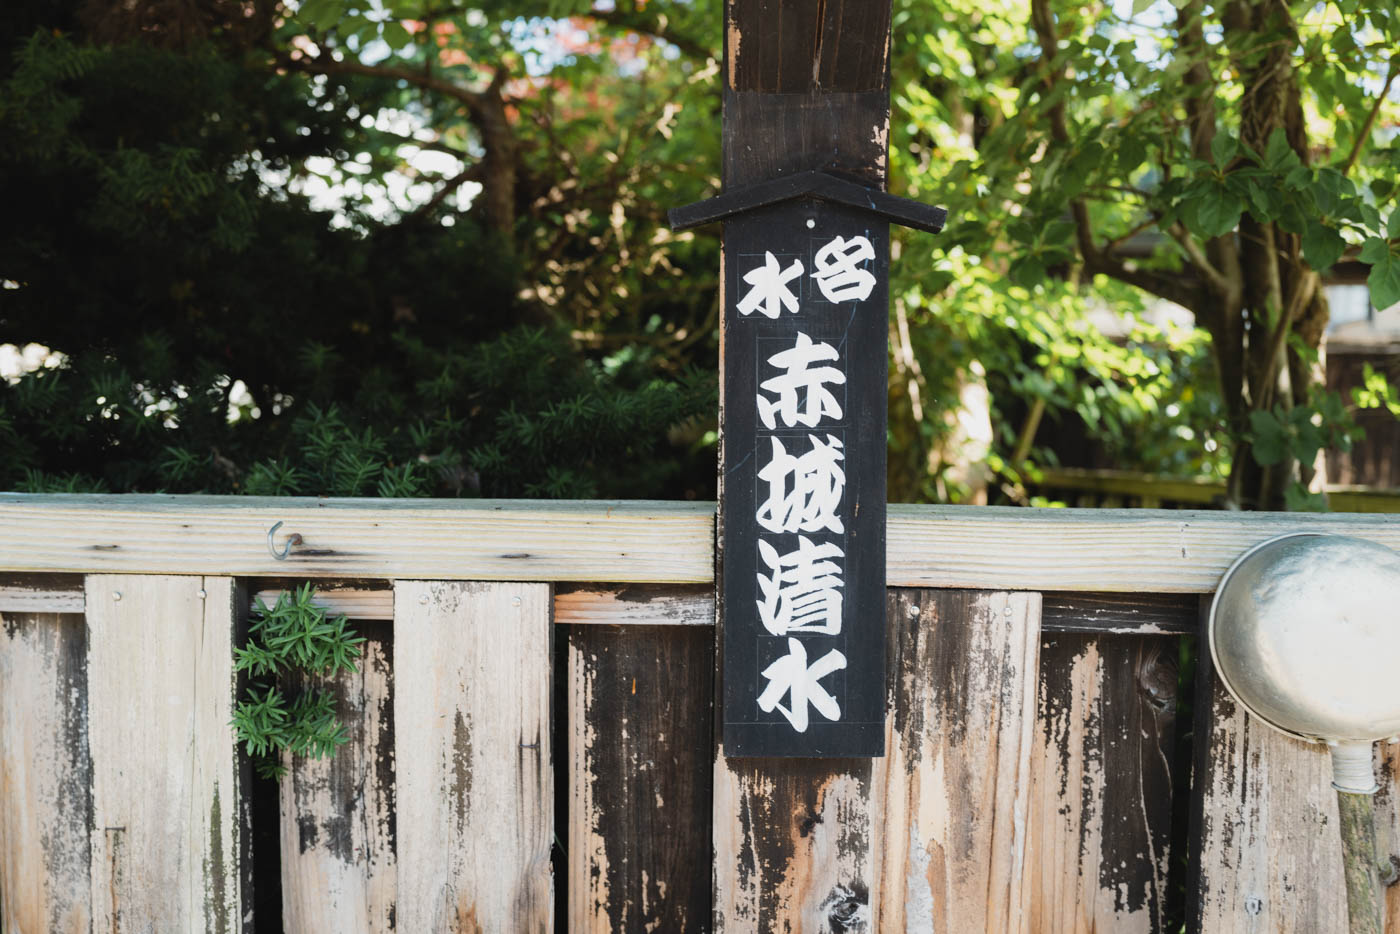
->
[0, 1, 715, 497]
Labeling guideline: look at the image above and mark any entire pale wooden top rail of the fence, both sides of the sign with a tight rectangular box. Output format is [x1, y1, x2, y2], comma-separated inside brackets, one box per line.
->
[0, 493, 1400, 594]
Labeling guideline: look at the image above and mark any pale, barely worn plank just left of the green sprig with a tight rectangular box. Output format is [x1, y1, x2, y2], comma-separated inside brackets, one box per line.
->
[87, 576, 244, 934]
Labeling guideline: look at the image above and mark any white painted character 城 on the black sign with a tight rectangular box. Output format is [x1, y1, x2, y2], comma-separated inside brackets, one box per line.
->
[756, 434, 846, 532]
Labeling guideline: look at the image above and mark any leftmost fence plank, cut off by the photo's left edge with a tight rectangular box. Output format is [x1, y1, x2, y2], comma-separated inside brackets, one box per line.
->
[0, 613, 92, 934]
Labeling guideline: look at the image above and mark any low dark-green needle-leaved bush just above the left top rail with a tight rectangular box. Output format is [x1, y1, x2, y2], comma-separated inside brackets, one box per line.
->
[0, 328, 715, 499]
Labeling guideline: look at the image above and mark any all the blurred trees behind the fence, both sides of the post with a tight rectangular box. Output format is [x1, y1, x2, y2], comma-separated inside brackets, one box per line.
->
[0, 0, 1400, 508]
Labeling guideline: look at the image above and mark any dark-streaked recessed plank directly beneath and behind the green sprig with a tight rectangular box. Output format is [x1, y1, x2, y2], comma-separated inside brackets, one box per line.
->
[280, 621, 402, 934]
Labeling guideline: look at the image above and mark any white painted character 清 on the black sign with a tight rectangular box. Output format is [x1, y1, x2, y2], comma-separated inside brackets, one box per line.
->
[757, 535, 846, 636]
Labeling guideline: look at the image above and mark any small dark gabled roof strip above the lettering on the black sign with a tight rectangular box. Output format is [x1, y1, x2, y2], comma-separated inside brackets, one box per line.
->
[666, 169, 948, 234]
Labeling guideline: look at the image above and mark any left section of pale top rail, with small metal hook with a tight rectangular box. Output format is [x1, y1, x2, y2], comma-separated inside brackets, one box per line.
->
[0, 493, 714, 583]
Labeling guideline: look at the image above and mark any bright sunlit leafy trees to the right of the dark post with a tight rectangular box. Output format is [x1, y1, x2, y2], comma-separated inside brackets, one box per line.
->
[890, 0, 1400, 508]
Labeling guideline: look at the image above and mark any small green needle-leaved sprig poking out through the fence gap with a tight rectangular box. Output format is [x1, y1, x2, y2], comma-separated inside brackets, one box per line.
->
[232, 583, 364, 779]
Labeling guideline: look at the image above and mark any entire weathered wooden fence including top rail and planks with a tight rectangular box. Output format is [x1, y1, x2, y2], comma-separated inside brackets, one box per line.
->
[0, 494, 1400, 934]
